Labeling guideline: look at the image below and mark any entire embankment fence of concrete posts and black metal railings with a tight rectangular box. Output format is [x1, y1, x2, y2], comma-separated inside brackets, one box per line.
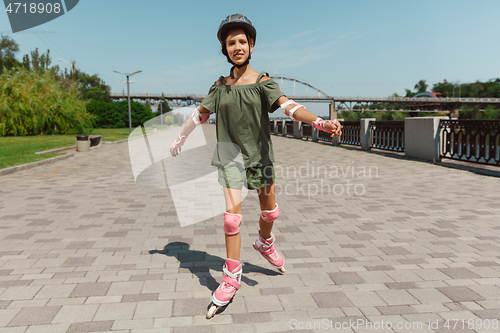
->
[270, 117, 500, 166]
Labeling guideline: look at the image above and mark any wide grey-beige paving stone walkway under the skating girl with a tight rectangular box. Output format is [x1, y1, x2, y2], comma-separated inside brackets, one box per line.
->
[0, 125, 500, 333]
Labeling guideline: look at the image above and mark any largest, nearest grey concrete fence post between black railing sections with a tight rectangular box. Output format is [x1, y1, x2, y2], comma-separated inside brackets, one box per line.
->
[404, 117, 448, 162]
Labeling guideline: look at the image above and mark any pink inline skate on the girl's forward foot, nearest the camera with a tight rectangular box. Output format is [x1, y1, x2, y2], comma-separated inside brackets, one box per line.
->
[207, 259, 242, 319]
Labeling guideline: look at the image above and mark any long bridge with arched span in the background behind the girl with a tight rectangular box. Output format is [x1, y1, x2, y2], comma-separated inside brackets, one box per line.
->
[111, 75, 500, 114]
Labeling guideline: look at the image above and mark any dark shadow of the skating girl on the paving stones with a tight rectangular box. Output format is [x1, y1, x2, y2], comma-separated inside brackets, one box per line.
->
[149, 242, 281, 291]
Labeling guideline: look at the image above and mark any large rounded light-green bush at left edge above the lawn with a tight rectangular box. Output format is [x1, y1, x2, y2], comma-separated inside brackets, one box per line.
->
[0, 68, 93, 136]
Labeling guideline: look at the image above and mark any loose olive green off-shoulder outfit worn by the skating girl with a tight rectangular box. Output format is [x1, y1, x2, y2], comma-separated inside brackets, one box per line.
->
[201, 72, 285, 189]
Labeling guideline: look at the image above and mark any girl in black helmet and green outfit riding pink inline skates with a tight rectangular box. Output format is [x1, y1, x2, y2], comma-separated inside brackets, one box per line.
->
[170, 14, 341, 318]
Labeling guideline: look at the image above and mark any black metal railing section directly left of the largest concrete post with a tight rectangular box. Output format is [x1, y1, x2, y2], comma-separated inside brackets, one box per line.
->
[370, 120, 405, 151]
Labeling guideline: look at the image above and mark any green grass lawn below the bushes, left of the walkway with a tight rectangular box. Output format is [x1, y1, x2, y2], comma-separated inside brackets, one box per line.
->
[0, 128, 129, 169]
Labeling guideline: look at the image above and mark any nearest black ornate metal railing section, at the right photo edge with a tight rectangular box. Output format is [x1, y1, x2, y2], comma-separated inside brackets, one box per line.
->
[439, 119, 500, 166]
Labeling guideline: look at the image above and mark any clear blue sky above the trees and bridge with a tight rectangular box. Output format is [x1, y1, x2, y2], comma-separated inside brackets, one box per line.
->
[0, 0, 500, 116]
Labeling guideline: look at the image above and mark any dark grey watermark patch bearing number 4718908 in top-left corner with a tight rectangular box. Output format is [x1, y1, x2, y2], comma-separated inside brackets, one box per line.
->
[3, 0, 79, 33]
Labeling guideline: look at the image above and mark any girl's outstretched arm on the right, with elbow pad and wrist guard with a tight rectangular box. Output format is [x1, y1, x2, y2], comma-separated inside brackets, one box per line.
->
[275, 96, 342, 137]
